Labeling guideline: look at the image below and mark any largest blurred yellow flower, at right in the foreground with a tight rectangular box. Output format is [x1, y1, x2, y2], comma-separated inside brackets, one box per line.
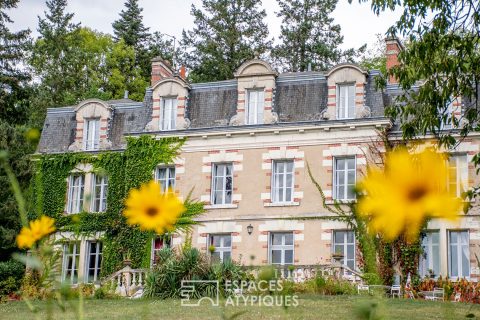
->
[357, 149, 462, 242]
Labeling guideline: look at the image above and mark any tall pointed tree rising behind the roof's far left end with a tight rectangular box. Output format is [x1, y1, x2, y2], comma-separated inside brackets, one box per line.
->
[30, 0, 79, 106]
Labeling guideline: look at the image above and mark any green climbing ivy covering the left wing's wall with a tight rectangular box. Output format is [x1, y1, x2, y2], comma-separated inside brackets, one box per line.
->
[30, 135, 203, 275]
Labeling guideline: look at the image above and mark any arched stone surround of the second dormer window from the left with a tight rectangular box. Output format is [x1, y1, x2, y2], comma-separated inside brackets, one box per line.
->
[145, 77, 190, 131]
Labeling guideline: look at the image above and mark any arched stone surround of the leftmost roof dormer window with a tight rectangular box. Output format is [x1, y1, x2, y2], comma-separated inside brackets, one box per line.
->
[68, 99, 113, 151]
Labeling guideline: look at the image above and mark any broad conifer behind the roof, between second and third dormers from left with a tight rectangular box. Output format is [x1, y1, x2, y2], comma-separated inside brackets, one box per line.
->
[182, 0, 271, 82]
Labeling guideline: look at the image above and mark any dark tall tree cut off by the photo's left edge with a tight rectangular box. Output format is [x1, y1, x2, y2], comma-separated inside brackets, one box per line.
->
[0, 0, 34, 261]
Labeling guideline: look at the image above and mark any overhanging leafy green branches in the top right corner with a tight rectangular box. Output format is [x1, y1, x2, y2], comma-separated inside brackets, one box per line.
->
[361, 0, 480, 149]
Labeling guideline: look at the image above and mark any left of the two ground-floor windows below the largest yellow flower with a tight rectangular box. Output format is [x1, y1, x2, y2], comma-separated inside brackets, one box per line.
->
[418, 231, 440, 277]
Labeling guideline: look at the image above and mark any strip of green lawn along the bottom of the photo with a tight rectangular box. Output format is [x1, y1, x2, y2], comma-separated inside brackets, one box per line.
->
[0, 295, 480, 320]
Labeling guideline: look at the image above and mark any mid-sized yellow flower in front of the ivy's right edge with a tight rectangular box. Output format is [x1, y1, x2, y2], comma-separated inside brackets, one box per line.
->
[123, 181, 186, 234]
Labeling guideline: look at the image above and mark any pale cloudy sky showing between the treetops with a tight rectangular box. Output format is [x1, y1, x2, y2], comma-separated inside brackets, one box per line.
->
[9, 0, 402, 49]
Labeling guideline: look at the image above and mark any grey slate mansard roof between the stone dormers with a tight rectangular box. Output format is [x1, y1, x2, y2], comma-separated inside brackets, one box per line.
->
[37, 66, 395, 153]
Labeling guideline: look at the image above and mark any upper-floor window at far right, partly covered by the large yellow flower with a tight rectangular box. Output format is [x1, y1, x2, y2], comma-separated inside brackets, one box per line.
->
[448, 154, 468, 197]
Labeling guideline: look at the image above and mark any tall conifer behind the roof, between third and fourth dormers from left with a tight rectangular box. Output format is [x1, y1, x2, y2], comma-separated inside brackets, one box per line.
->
[272, 0, 365, 72]
